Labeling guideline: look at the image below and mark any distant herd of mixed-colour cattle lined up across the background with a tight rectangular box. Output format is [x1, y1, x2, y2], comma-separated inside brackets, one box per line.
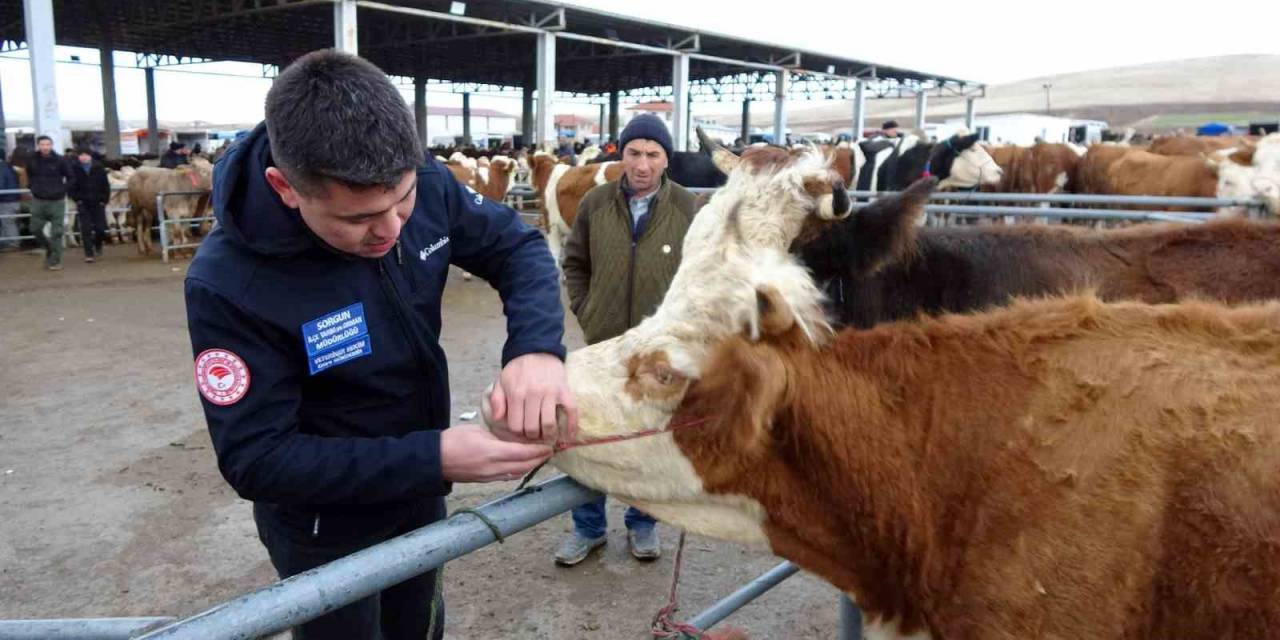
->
[17, 127, 1280, 259]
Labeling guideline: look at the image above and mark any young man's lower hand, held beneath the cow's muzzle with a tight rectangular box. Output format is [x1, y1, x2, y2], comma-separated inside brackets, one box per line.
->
[440, 425, 552, 483]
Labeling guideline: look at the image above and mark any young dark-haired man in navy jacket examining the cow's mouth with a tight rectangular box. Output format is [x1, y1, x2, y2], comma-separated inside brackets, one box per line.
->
[186, 50, 576, 640]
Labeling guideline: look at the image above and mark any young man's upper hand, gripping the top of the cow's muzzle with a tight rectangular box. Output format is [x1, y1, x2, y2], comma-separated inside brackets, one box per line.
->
[489, 353, 577, 442]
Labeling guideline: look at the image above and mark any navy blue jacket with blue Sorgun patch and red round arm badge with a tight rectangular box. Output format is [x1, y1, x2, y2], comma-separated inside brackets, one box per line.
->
[186, 124, 564, 513]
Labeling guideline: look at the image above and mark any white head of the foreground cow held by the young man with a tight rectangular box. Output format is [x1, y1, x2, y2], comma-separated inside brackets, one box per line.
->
[488, 147, 851, 535]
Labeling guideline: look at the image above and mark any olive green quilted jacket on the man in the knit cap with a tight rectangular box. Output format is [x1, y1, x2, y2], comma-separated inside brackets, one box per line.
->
[563, 177, 696, 344]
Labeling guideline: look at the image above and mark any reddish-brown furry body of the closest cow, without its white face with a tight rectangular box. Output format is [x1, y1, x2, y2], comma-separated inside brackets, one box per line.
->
[670, 298, 1280, 640]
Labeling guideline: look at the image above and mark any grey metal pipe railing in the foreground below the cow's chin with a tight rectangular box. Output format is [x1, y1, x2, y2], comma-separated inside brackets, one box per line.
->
[0, 476, 861, 640]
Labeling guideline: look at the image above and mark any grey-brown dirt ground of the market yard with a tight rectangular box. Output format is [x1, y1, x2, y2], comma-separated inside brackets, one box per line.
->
[0, 246, 837, 640]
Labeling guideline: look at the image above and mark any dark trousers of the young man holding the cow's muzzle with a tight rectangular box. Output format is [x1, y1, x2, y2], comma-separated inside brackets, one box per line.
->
[253, 498, 445, 640]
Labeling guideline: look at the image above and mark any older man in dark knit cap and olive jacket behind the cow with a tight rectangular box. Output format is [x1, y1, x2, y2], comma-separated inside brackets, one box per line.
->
[556, 114, 696, 566]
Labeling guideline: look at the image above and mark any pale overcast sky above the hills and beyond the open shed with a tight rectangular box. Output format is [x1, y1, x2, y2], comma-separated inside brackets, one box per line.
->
[0, 0, 1280, 123]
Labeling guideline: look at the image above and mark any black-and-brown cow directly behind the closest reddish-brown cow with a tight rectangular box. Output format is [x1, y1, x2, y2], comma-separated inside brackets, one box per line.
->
[797, 190, 1280, 326]
